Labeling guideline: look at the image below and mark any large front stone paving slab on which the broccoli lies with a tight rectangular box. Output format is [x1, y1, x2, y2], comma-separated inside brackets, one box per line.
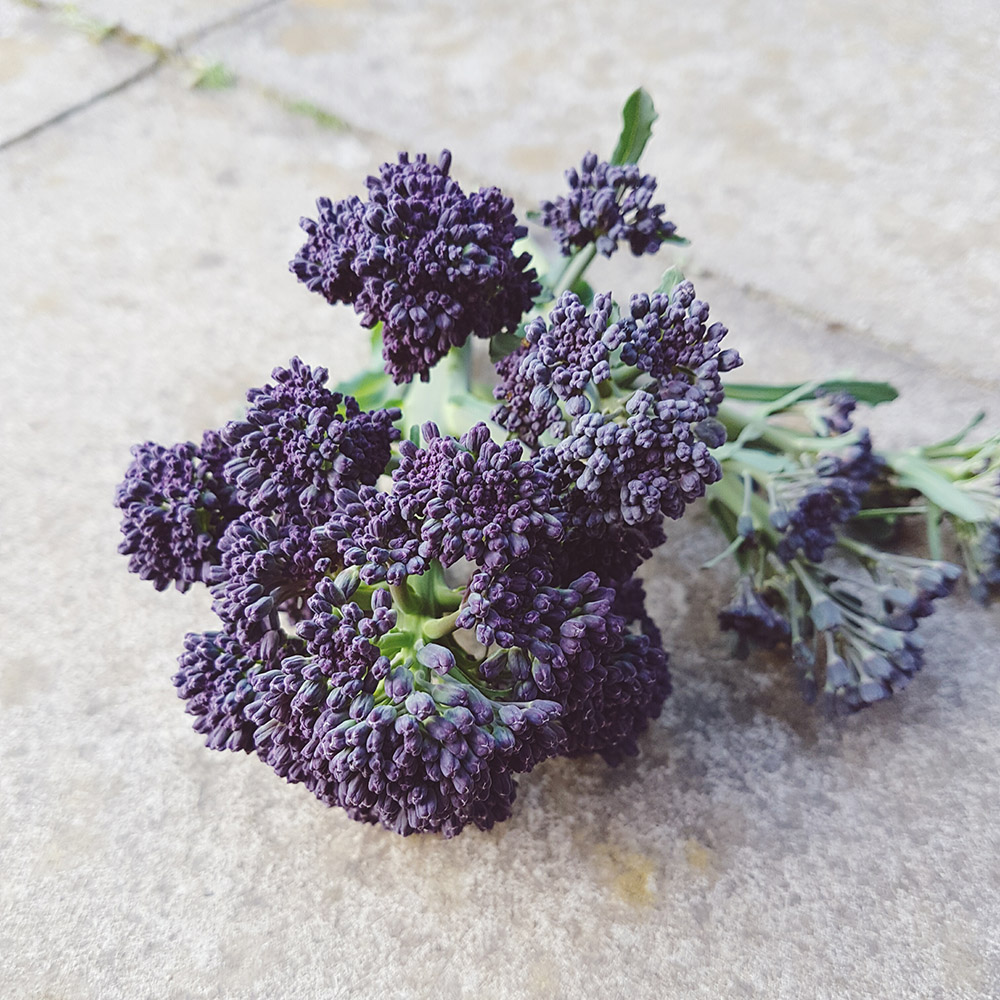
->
[0, 7, 1000, 1000]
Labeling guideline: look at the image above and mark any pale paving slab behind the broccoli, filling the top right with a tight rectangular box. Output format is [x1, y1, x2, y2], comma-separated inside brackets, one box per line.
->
[191, 0, 1000, 380]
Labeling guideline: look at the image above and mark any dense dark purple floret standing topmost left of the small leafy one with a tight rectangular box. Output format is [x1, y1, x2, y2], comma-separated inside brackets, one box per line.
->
[290, 150, 541, 382]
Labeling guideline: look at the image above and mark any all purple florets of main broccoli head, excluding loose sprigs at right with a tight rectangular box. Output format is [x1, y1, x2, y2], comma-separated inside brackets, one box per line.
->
[118, 131, 728, 837]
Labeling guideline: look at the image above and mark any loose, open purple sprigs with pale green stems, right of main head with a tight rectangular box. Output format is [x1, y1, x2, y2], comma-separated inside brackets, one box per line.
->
[712, 384, 972, 713]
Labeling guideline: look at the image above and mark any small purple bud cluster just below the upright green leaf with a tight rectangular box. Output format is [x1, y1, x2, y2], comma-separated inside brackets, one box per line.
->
[541, 153, 681, 257]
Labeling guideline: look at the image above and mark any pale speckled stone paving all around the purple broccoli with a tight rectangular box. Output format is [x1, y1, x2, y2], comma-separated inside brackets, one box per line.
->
[0, 0, 1000, 1000]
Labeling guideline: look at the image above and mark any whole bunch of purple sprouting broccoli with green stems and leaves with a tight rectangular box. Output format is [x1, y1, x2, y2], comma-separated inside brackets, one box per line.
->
[117, 90, 1000, 836]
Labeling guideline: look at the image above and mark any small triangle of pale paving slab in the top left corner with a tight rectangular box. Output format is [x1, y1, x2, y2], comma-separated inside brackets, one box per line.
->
[0, 0, 153, 146]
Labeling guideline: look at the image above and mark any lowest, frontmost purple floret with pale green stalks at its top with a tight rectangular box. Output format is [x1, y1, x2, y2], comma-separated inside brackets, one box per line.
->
[175, 570, 565, 836]
